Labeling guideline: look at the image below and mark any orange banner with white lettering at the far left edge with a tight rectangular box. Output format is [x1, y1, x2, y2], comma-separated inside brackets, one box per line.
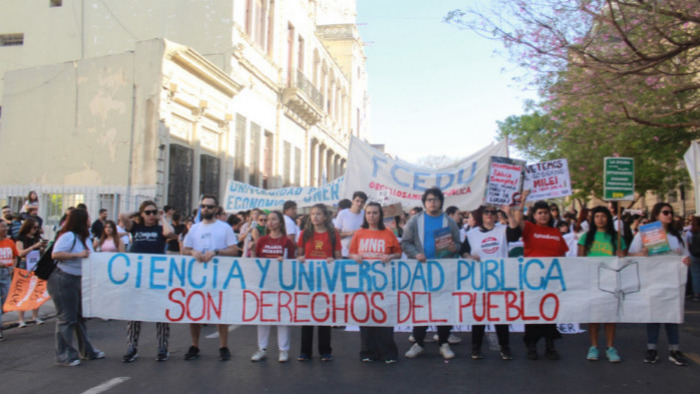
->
[2, 268, 51, 312]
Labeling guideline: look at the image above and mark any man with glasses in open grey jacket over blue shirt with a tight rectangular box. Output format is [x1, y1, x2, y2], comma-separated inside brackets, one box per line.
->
[401, 187, 460, 359]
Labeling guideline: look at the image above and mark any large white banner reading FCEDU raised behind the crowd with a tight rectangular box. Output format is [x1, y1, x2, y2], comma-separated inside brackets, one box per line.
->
[341, 137, 507, 210]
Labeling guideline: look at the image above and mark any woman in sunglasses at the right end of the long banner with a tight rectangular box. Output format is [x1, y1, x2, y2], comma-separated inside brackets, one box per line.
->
[629, 202, 690, 366]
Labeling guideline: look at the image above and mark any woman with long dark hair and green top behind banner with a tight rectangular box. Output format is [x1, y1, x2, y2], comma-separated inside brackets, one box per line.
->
[578, 206, 627, 363]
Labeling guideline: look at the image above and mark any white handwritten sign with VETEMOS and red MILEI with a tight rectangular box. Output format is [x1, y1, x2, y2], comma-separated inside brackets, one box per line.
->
[523, 159, 571, 201]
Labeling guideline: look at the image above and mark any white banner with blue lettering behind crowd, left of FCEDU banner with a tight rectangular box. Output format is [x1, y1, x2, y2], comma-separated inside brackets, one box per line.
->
[223, 177, 343, 212]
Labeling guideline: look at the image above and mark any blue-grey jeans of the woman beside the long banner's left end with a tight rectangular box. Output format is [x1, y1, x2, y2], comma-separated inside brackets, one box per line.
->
[46, 267, 99, 364]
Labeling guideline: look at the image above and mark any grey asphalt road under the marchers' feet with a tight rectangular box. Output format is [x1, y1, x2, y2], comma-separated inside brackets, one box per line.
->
[0, 301, 700, 394]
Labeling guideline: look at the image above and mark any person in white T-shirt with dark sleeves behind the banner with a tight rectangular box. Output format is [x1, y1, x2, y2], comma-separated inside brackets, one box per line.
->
[459, 205, 523, 360]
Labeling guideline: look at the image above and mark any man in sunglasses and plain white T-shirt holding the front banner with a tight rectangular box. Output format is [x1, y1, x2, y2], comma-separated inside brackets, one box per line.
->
[183, 195, 238, 361]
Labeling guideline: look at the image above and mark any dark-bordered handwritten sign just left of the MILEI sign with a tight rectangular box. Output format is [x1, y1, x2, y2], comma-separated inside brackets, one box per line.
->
[484, 156, 525, 205]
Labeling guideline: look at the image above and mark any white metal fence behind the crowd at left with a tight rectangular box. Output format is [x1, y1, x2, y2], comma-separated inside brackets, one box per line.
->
[0, 185, 155, 238]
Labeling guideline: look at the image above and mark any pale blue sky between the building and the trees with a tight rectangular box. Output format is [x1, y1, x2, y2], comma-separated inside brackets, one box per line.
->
[357, 0, 537, 163]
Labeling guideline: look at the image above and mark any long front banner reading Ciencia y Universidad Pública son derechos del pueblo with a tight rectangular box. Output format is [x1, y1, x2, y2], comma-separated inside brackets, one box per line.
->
[82, 253, 687, 326]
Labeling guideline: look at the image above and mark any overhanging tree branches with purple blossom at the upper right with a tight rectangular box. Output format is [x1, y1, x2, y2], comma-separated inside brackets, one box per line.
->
[445, 0, 700, 129]
